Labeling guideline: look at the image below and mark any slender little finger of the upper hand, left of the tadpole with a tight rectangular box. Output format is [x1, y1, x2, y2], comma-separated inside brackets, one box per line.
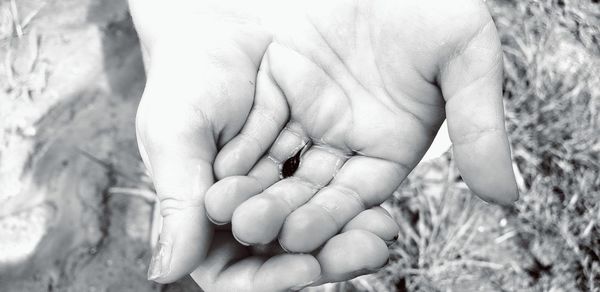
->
[215, 50, 289, 179]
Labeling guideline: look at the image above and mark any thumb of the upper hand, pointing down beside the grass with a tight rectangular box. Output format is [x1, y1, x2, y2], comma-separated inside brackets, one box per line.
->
[440, 19, 518, 204]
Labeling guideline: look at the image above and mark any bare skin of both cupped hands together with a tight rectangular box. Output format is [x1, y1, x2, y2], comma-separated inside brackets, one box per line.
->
[130, 0, 518, 291]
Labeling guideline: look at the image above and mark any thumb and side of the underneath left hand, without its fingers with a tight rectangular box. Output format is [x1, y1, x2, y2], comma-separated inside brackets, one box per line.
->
[130, 0, 271, 283]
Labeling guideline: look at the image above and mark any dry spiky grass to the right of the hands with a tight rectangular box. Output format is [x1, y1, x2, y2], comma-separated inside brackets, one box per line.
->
[334, 0, 600, 291]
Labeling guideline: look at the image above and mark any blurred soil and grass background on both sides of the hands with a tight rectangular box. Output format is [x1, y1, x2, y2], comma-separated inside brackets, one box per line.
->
[0, 0, 600, 291]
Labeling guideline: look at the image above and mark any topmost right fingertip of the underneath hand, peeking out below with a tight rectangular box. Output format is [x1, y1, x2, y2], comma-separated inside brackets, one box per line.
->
[342, 206, 400, 245]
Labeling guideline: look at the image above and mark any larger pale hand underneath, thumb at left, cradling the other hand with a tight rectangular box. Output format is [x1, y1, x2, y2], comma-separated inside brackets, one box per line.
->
[130, 0, 398, 291]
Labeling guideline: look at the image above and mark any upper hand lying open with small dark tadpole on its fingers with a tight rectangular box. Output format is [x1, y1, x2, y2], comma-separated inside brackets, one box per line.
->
[206, 1, 518, 252]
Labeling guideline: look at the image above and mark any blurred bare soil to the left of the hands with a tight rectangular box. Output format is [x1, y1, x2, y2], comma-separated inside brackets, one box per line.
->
[0, 0, 195, 291]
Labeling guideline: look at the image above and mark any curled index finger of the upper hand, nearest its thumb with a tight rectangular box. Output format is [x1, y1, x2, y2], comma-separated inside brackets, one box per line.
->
[279, 156, 408, 252]
